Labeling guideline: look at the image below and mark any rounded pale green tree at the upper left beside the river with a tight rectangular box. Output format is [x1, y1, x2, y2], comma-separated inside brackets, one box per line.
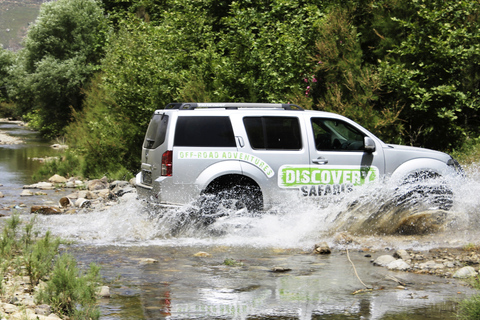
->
[11, 0, 108, 136]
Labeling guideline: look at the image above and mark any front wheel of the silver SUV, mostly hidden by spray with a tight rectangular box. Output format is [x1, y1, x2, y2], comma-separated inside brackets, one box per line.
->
[396, 172, 453, 211]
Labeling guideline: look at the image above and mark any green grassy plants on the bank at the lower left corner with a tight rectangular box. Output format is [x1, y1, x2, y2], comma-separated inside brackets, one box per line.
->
[0, 214, 101, 320]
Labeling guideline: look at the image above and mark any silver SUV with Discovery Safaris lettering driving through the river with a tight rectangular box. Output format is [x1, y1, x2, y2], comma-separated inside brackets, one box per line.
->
[136, 103, 461, 211]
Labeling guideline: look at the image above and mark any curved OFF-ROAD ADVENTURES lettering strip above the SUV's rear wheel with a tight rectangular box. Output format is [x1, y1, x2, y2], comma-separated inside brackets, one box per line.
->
[178, 151, 275, 178]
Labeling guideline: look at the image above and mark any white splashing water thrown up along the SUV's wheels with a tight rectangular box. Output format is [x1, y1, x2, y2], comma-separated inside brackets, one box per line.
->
[34, 166, 480, 248]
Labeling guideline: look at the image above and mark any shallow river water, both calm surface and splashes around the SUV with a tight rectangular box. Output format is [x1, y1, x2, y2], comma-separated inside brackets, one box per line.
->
[0, 120, 480, 320]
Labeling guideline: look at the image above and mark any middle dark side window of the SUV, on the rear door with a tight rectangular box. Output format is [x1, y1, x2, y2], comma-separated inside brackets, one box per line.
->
[243, 117, 302, 150]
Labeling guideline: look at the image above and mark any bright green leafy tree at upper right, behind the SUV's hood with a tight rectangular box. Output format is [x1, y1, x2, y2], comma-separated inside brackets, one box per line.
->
[379, 0, 480, 149]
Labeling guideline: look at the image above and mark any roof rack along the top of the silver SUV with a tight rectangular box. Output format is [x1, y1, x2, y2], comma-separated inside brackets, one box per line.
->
[165, 102, 304, 111]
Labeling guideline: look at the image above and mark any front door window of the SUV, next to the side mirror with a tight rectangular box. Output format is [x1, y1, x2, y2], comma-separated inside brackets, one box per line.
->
[312, 118, 365, 151]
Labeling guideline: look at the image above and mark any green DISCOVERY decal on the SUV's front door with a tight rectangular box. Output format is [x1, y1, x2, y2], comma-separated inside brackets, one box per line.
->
[278, 165, 379, 188]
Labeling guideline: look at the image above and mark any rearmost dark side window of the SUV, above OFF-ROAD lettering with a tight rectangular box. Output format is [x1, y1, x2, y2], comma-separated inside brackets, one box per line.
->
[174, 117, 236, 147]
